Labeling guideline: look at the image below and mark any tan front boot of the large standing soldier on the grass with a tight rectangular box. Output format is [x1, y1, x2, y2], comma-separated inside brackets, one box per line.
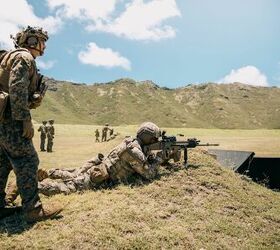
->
[24, 204, 63, 223]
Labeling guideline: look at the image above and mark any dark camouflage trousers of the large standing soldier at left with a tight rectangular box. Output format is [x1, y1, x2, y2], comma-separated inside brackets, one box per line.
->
[0, 119, 41, 211]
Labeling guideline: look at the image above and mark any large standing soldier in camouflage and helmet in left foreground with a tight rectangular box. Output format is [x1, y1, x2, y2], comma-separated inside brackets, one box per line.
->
[0, 26, 62, 222]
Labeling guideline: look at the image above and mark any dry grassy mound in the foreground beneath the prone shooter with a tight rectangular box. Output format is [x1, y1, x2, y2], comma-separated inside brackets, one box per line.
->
[0, 149, 280, 249]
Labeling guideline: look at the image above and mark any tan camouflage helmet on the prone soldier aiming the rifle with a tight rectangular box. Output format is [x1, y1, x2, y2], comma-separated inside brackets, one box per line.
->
[137, 122, 161, 145]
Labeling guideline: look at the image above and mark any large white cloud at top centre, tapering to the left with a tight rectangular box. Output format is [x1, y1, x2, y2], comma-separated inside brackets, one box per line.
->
[87, 0, 181, 40]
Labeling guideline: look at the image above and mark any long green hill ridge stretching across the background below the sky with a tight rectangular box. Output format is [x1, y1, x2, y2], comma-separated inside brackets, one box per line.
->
[33, 78, 280, 129]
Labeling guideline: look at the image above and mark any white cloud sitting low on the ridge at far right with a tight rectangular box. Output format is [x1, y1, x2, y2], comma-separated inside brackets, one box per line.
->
[218, 65, 268, 86]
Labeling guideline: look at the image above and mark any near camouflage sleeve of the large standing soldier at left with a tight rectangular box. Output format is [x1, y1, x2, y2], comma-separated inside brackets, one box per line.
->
[9, 55, 31, 120]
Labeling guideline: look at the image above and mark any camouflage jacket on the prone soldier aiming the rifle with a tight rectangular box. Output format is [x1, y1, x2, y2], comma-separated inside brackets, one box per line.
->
[103, 138, 161, 181]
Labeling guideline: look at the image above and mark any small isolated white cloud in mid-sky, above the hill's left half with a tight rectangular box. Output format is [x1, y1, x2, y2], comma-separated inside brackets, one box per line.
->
[78, 43, 131, 70]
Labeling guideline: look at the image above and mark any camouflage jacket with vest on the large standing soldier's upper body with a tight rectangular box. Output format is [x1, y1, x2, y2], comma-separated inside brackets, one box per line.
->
[0, 48, 38, 120]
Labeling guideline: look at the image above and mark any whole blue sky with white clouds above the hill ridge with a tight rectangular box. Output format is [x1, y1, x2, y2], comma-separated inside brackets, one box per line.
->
[0, 0, 280, 88]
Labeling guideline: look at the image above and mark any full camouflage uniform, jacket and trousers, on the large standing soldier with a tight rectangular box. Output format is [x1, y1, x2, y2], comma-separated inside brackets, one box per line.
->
[0, 48, 41, 211]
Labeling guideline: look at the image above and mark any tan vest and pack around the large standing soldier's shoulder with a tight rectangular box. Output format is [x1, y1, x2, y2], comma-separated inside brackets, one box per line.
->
[0, 48, 38, 93]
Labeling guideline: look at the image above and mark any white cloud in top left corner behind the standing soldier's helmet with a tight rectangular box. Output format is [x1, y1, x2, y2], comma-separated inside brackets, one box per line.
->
[0, 0, 62, 49]
